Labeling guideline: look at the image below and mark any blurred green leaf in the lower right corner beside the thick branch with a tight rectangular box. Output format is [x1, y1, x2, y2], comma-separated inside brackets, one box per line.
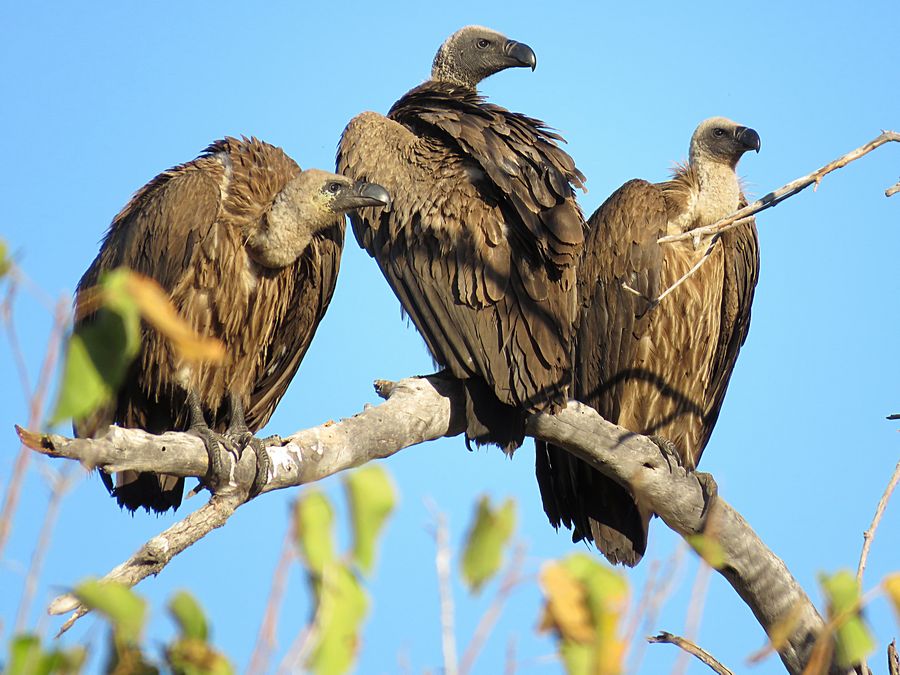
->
[819, 570, 875, 668]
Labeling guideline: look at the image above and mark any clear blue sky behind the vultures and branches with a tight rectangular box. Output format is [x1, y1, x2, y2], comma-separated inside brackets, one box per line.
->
[0, 0, 900, 673]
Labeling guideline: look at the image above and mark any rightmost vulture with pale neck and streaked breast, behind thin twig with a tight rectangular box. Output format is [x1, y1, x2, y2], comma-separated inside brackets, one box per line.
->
[537, 117, 759, 565]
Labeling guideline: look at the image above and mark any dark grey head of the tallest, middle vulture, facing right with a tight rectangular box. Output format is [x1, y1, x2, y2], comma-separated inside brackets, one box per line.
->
[431, 26, 537, 89]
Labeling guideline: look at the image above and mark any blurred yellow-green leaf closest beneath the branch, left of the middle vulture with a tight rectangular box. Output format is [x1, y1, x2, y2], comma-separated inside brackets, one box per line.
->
[344, 465, 397, 574]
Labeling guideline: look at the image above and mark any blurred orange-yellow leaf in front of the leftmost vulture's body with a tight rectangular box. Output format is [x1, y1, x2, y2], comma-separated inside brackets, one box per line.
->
[125, 272, 225, 363]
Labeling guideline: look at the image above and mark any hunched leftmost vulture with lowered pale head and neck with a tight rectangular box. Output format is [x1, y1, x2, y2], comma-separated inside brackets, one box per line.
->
[75, 138, 389, 513]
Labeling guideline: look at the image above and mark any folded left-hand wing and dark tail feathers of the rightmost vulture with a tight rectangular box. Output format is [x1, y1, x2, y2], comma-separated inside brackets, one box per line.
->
[536, 180, 667, 565]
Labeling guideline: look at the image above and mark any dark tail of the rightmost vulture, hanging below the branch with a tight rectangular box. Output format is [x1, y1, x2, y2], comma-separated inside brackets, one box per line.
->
[535, 441, 649, 567]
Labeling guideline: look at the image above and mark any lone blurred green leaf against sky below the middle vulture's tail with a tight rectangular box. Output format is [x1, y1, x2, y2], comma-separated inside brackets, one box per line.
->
[462, 496, 516, 593]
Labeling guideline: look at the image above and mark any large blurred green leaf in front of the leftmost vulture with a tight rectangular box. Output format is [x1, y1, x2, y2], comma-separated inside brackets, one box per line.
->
[50, 269, 141, 425]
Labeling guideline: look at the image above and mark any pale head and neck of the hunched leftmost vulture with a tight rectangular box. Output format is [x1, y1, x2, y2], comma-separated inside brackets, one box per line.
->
[244, 169, 391, 268]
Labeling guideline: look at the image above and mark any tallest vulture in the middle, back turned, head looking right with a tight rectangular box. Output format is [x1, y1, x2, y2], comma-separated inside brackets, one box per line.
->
[337, 26, 585, 453]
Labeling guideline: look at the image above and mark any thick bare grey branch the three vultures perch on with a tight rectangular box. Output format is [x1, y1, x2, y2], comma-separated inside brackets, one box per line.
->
[19, 376, 852, 673]
